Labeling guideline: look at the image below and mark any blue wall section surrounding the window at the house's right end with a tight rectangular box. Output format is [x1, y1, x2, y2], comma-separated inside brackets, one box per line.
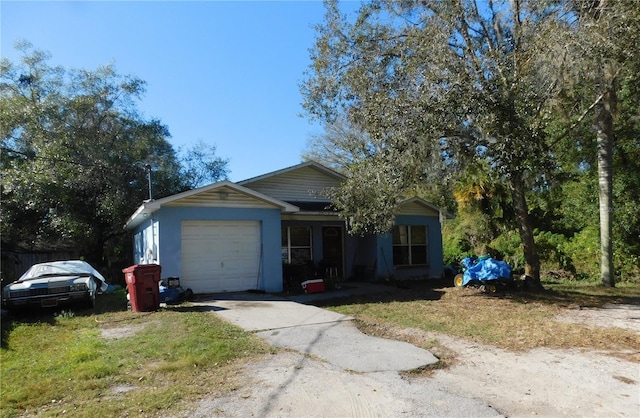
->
[376, 215, 444, 279]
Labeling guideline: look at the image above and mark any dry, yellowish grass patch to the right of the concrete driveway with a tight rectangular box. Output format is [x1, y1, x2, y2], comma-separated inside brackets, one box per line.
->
[325, 281, 640, 361]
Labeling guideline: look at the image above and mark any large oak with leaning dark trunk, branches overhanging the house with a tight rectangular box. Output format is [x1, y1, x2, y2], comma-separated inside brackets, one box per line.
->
[301, 0, 572, 284]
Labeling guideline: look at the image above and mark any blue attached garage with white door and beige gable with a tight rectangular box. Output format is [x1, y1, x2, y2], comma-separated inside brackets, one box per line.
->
[126, 180, 299, 294]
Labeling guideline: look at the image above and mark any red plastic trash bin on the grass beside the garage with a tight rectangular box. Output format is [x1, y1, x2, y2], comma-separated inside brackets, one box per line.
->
[122, 264, 162, 312]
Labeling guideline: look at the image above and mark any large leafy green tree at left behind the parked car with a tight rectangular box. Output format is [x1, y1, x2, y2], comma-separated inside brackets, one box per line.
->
[0, 42, 227, 272]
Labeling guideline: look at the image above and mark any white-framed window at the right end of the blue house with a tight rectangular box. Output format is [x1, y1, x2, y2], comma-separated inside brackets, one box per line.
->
[393, 225, 429, 266]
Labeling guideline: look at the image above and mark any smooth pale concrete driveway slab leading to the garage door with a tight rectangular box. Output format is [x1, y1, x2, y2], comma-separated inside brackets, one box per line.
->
[194, 288, 438, 372]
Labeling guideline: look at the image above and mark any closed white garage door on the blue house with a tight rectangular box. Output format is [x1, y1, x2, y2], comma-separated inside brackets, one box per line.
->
[180, 221, 260, 293]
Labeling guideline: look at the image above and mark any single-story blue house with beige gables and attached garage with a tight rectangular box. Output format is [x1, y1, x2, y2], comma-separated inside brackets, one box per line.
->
[125, 162, 443, 293]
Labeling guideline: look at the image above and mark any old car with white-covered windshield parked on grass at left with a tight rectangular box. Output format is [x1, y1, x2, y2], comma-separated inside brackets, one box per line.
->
[2, 260, 108, 309]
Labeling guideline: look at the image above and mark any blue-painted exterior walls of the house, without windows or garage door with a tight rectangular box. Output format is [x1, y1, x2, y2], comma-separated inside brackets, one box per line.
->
[133, 207, 443, 293]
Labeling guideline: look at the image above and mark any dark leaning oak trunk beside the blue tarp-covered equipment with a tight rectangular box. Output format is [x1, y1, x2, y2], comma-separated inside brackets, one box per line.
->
[511, 173, 543, 290]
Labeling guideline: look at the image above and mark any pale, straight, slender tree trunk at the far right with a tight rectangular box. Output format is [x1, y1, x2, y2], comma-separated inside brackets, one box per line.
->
[595, 89, 616, 287]
